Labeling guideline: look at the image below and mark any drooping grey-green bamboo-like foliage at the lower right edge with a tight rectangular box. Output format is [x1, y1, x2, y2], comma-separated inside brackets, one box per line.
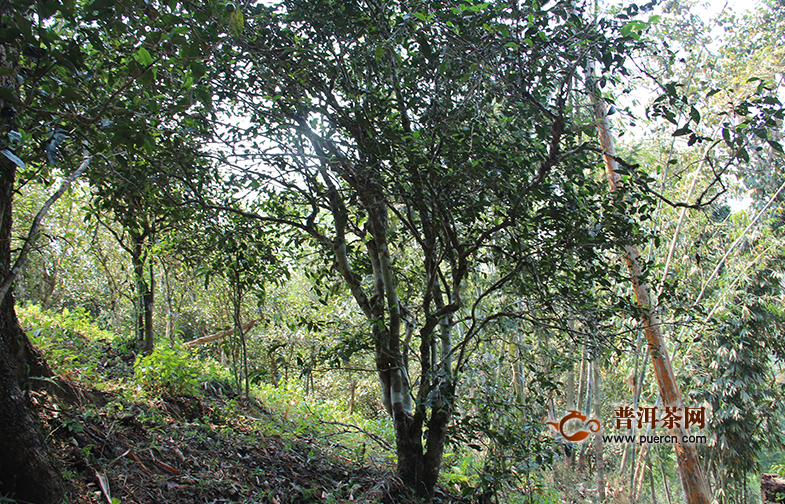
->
[695, 262, 785, 499]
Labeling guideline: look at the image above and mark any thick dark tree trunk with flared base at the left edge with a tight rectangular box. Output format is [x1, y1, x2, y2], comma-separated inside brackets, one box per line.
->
[0, 36, 63, 504]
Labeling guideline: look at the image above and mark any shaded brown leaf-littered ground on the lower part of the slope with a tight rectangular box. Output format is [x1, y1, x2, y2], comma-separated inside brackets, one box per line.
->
[30, 376, 462, 504]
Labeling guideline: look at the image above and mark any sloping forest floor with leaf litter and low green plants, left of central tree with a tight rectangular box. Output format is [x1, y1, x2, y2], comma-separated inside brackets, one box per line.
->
[16, 309, 468, 504]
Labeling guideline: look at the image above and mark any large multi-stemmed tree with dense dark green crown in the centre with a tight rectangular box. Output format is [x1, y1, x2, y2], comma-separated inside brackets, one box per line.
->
[205, 1, 648, 499]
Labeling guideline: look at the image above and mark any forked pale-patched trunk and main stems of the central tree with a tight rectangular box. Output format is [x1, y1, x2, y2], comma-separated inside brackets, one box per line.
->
[304, 118, 454, 503]
